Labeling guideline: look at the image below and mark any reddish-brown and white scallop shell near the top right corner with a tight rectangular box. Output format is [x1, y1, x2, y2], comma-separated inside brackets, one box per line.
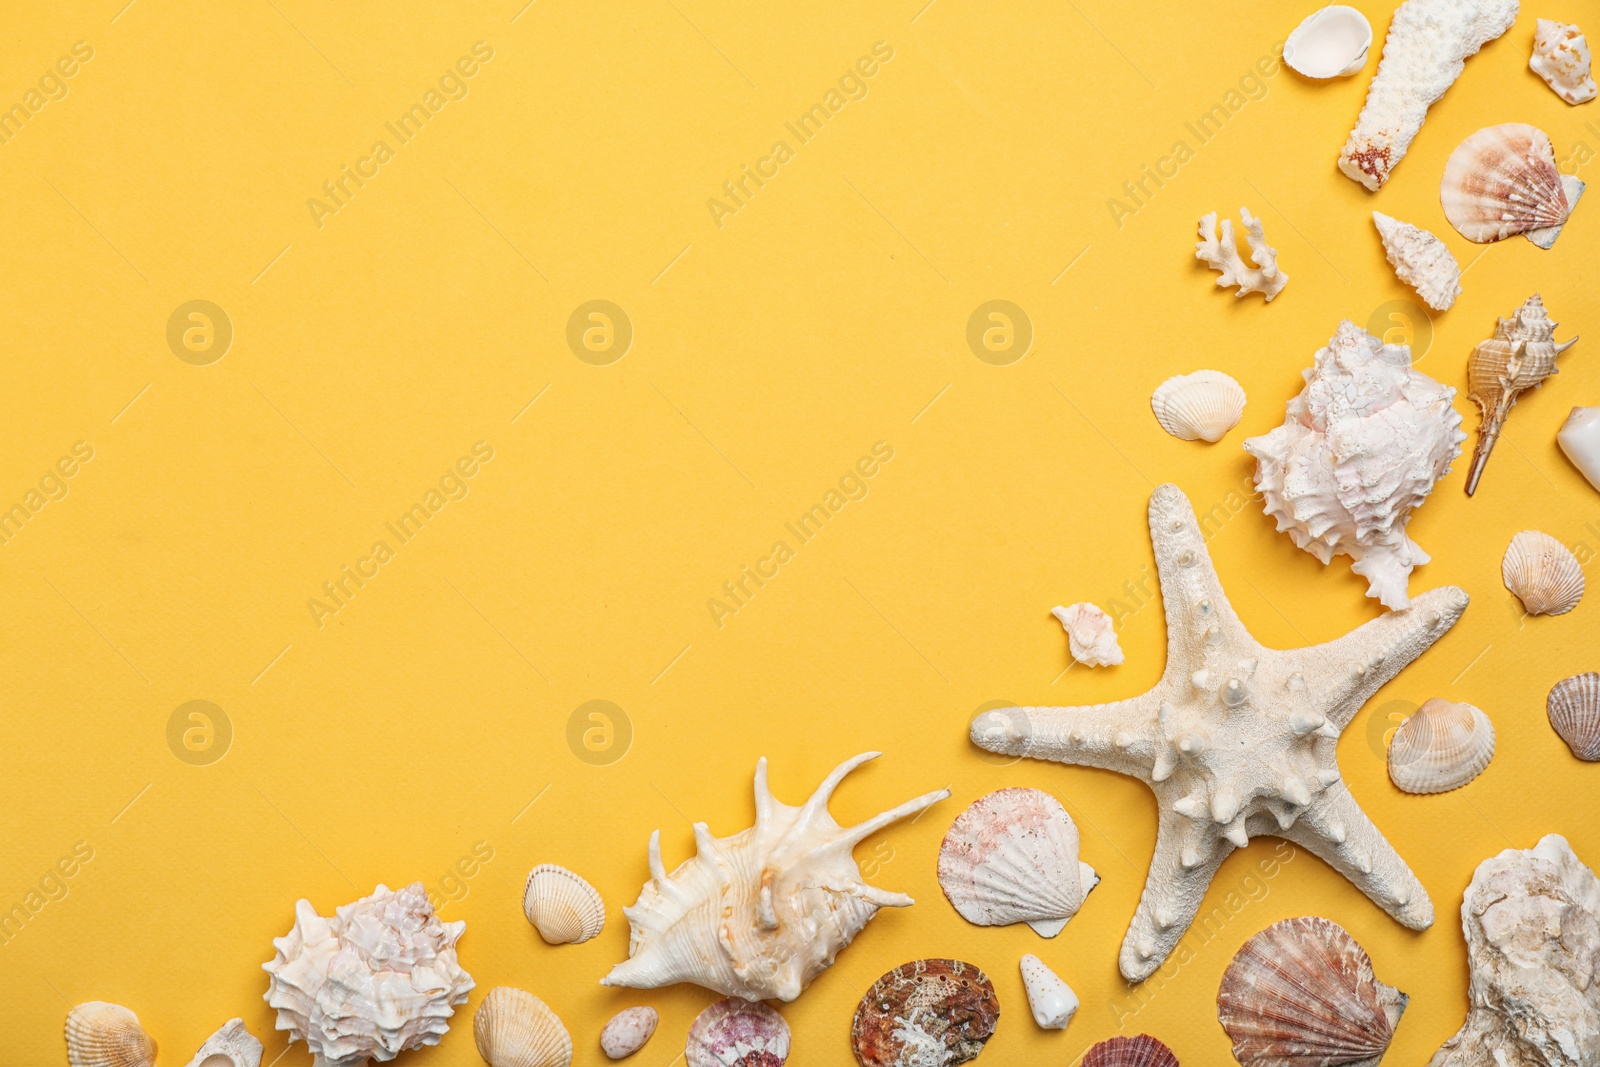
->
[1438, 122, 1584, 248]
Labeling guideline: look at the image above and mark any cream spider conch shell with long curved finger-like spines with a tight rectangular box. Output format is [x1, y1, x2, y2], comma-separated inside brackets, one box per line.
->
[600, 752, 950, 1001]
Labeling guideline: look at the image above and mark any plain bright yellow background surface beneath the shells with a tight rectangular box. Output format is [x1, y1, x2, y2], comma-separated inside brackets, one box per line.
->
[0, 0, 1600, 1067]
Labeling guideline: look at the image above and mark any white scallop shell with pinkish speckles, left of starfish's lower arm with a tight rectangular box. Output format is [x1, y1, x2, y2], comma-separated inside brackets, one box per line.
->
[939, 789, 1099, 937]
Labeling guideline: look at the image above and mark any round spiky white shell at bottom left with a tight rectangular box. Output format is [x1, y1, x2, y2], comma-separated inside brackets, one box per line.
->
[261, 881, 474, 1067]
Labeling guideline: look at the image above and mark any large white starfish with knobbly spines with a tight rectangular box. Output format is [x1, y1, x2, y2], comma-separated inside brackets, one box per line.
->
[971, 485, 1467, 982]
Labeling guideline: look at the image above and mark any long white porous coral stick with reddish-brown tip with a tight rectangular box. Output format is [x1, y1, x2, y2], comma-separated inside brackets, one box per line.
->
[1339, 0, 1517, 190]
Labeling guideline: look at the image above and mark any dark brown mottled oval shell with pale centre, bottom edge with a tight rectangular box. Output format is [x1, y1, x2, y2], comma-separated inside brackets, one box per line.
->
[850, 960, 1000, 1067]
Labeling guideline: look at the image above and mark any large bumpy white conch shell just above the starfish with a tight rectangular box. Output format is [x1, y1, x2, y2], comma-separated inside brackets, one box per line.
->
[1245, 319, 1466, 609]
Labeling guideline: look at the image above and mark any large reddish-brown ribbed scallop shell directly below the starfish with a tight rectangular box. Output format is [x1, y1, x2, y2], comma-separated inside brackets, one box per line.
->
[1216, 915, 1408, 1067]
